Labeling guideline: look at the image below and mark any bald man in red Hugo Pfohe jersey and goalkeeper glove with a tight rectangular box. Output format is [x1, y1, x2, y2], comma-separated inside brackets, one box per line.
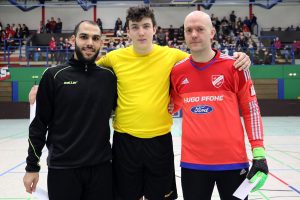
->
[171, 11, 268, 200]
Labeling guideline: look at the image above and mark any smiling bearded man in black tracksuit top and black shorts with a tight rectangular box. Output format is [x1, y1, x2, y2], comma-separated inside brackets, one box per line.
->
[23, 21, 117, 200]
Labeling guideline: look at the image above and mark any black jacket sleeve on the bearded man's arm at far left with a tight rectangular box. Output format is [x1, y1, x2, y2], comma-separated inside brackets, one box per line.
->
[25, 70, 54, 172]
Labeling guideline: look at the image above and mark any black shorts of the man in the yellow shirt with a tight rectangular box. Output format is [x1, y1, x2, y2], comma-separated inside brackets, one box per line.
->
[112, 131, 177, 200]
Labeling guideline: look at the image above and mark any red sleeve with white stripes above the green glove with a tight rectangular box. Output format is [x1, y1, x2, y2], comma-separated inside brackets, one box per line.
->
[236, 70, 264, 149]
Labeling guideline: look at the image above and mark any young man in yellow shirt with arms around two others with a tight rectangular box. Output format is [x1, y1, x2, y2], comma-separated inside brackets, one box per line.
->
[29, 7, 250, 200]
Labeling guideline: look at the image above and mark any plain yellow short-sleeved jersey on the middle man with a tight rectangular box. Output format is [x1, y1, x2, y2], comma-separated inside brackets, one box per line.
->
[96, 44, 189, 138]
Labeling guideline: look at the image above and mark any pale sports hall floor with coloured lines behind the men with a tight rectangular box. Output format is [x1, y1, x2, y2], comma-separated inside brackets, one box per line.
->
[0, 117, 300, 200]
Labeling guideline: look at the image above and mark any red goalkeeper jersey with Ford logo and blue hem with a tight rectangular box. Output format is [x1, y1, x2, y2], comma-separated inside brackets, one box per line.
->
[171, 51, 263, 171]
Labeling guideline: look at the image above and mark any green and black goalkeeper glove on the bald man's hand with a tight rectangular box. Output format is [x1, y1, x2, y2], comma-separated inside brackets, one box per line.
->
[247, 147, 269, 192]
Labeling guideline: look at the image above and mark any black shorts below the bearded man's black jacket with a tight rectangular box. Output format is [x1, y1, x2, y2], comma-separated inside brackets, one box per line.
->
[47, 161, 113, 200]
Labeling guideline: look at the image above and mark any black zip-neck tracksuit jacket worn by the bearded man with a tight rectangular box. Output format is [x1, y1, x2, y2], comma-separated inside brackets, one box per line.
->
[26, 58, 117, 172]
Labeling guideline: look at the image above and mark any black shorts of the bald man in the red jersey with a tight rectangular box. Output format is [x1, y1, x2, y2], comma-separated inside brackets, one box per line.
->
[181, 168, 248, 200]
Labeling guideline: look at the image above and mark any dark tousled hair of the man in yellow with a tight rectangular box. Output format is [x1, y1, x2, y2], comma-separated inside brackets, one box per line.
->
[126, 6, 156, 26]
